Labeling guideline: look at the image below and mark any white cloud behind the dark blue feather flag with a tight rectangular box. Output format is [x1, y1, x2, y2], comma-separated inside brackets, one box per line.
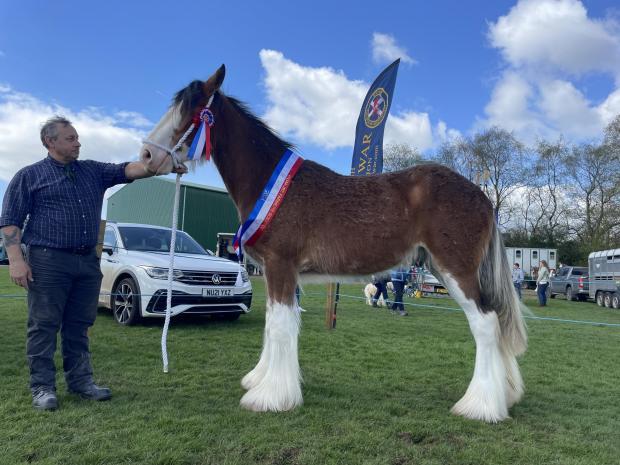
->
[260, 50, 446, 150]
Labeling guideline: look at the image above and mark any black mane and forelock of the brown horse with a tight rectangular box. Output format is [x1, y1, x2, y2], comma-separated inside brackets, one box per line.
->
[172, 80, 295, 150]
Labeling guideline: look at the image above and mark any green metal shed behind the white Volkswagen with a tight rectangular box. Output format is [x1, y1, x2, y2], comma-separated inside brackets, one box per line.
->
[106, 177, 239, 251]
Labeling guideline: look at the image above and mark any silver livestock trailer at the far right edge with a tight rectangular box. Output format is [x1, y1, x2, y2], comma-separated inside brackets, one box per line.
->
[588, 249, 620, 309]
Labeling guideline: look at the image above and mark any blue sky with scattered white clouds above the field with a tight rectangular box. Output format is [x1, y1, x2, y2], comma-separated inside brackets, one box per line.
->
[0, 0, 620, 214]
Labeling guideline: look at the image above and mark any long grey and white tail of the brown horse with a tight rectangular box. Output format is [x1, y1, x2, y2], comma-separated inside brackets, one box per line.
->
[478, 221, 527, 355]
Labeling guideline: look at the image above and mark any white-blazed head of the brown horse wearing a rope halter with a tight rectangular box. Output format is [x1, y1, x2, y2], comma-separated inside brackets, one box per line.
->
[140, 65, 226, 174]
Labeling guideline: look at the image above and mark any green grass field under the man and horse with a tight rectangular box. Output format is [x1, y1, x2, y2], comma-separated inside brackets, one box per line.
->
[0, 269, 620, 465]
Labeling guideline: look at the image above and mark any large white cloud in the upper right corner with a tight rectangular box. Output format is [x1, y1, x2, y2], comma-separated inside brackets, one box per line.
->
[482, 0, 620, 142]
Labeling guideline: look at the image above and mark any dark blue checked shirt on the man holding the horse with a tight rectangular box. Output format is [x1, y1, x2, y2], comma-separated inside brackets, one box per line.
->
[0, 155, 131, 249]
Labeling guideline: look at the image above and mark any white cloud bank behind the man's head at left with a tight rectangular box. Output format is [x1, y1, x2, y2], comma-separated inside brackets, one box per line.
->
[0, 86, 146, 181]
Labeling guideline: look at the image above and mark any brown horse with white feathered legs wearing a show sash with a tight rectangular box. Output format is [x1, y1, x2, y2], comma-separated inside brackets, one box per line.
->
[140, 65, 527, 423]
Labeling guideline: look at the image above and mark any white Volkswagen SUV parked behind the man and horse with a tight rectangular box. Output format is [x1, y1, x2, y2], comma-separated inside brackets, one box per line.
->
[99, 223, 252, 325]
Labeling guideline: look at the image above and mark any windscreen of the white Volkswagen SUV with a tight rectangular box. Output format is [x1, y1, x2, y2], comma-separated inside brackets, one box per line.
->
[118, 226, 210, 255]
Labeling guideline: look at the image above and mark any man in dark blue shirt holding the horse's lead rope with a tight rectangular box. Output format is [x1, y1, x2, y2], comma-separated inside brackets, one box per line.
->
[0, 116, 187, 410]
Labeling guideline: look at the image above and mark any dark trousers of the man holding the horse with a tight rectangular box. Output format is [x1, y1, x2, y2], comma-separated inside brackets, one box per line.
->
[26, 246, 102, 391]
